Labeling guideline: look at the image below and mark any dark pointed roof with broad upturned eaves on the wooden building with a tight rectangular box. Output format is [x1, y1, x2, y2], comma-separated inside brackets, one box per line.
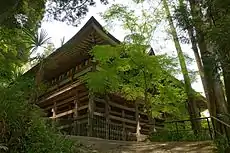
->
[26, 17, 120, 80]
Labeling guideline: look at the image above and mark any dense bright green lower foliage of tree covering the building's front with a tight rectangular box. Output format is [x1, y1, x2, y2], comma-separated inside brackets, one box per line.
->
[83, 44, 185, 116]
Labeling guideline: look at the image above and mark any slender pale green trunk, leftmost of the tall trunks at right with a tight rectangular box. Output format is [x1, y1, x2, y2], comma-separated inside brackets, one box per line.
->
[163, 0, 200, 133]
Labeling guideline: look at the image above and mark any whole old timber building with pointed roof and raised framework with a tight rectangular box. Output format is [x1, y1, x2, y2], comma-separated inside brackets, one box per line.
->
[28, 17, 207, 140]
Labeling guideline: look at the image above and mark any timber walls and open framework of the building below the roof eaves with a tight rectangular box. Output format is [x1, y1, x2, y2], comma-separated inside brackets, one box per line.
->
[38, 60, 157, 140]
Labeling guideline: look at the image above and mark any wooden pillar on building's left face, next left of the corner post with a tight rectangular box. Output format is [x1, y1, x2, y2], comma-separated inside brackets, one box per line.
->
[73, 91, 80, 135]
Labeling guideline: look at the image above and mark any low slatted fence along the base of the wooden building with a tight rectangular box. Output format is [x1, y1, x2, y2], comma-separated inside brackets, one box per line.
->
[57, 116, 135, 140]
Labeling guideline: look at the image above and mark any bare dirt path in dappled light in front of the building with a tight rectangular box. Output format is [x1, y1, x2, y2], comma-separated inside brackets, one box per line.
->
[70, 136, 214, 153]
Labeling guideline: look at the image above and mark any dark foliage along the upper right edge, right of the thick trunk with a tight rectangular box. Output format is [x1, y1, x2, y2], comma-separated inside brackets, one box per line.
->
[205, 0, 230, 112]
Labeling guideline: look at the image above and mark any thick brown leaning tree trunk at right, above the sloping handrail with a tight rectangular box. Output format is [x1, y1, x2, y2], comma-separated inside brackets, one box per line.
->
[189, 0, 227, 132]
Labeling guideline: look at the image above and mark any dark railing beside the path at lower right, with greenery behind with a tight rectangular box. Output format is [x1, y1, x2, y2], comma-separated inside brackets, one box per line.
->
[151, 116, 230, 152]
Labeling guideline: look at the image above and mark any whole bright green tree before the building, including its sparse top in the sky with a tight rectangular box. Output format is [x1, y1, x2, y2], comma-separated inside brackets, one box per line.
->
[84, 5, 188, 117]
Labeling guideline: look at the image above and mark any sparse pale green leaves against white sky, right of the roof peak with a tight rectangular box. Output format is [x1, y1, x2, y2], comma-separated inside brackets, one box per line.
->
[102, 4, 163, 45]
